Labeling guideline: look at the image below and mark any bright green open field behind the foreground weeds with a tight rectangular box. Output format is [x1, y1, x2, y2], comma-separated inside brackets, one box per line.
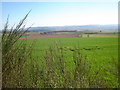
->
[23, 36, 118, 87]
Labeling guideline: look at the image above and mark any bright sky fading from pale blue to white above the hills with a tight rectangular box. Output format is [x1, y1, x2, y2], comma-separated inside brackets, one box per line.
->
[2, 0, 118, 29]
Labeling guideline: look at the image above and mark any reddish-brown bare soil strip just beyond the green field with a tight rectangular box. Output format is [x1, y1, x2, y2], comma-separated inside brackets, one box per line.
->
[20, 34, 78, 39]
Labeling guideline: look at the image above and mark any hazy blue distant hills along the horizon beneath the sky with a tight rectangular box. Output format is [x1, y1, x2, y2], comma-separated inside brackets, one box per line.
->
[29, 24, 118, 31]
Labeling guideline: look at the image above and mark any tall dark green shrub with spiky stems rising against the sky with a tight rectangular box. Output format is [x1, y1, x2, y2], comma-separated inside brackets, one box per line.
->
[2, 13, 31, 88]
